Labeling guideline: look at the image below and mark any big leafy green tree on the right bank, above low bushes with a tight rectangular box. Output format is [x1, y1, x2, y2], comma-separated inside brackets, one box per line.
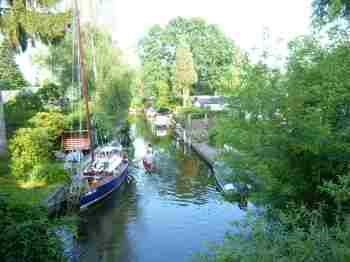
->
[218, 37, 350, 217]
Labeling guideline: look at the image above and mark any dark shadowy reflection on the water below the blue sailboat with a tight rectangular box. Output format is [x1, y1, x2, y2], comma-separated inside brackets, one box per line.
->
[79, 185, 139, 262]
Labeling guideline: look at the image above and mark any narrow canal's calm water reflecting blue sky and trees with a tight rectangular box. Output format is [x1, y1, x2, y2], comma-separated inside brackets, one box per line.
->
[79, 119, 249, 262]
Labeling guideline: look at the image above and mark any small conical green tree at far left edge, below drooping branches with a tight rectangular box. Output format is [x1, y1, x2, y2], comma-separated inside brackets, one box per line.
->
[0, 39, 27, 90]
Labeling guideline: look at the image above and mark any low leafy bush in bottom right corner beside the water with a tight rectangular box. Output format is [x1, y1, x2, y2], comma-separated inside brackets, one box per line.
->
[199, 210, 350, 262]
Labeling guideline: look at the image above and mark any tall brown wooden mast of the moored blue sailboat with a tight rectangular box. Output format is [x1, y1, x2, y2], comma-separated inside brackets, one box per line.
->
[74, 0, 95, 161]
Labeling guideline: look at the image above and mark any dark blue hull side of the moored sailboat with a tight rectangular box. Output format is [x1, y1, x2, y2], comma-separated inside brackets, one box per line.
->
[80, 167, 128, 210]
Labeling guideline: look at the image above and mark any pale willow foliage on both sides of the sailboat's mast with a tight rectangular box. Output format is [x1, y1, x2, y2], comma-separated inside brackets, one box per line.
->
[36, 26, 135, 140]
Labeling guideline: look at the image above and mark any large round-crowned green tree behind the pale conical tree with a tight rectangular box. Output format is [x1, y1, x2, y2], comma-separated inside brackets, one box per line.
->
[138, 17, 242, 100]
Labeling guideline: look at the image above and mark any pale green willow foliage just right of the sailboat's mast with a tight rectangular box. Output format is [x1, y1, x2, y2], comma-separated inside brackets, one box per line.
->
[90, 29, 135, 135]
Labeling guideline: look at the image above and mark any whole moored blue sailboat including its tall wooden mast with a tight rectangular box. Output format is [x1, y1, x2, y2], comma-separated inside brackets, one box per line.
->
[67, 0, 129, 210]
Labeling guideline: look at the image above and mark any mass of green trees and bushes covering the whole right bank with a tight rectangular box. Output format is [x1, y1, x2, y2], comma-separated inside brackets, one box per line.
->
[200, 0, 350, 261]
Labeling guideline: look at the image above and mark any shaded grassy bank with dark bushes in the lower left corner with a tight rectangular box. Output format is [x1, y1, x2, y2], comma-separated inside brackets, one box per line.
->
[0, 157, 77, 261]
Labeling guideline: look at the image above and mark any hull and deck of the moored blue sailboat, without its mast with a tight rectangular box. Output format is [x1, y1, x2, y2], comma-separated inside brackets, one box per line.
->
[80, 146, 128, 209]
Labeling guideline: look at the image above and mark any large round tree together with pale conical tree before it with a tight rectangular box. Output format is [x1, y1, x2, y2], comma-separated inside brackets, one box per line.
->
[138, 17, 243, 106]
